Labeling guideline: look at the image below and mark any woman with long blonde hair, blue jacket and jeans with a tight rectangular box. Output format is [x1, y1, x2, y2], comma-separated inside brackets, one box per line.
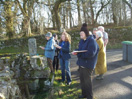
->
[57, 32, 72, 85]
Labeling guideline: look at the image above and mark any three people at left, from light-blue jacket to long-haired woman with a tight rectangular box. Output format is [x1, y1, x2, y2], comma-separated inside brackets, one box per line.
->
[41, 32, 72, 85]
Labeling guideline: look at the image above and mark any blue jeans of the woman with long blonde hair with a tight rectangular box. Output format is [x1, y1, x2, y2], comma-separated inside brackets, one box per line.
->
[60, 58, 71, 83]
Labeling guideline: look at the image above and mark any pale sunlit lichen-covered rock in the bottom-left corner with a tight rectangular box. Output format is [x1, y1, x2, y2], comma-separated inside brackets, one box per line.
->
[0, 66, 21, 99]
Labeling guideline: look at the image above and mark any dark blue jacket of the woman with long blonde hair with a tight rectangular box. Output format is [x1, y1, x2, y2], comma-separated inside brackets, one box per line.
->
[58, 42, 71, 60]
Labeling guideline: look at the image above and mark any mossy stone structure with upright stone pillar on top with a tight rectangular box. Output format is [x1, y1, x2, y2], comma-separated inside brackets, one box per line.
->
[0, 38, 54, 99]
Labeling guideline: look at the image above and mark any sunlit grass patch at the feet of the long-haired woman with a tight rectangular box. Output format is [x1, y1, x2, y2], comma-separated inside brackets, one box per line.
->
[34, 71, 81, 99]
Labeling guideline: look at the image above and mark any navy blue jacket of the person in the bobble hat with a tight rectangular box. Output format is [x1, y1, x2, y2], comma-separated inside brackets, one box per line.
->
[77, 36, 99, 69]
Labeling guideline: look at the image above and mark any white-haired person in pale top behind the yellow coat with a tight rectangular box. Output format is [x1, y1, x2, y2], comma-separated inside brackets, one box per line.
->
[98, 26, 108, 51]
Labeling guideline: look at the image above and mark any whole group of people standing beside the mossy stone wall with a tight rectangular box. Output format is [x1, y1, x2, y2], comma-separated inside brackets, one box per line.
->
[42, 23, 108, 99]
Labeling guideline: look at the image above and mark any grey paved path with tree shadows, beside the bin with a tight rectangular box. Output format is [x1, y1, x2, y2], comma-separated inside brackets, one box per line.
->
[71, 50, 132, 99]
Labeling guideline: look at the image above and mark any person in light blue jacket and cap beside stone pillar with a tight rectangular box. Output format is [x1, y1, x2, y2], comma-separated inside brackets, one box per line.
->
[42, 32, 56, 73]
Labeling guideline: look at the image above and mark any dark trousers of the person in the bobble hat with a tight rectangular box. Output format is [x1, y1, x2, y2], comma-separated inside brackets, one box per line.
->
[79, 67, 93, 99]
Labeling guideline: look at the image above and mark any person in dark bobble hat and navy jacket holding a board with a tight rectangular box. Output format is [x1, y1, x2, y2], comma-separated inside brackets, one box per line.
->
[72, 26, 99, 99]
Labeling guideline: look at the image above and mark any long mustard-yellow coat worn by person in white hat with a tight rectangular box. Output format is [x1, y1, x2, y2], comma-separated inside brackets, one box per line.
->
[95, 38, 107, 74]
